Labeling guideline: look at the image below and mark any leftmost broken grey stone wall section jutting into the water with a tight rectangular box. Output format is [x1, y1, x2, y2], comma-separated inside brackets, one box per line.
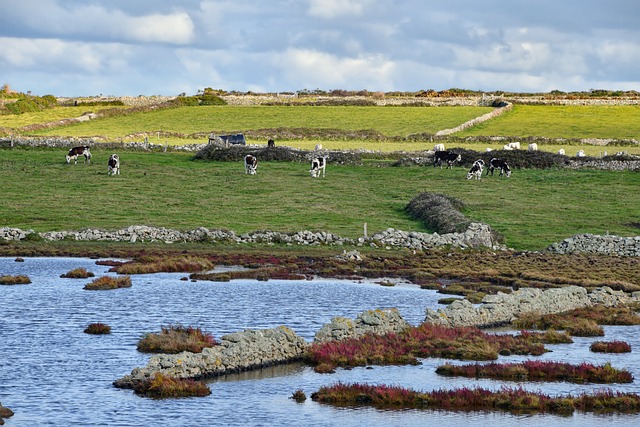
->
[113, 326, 309, 388]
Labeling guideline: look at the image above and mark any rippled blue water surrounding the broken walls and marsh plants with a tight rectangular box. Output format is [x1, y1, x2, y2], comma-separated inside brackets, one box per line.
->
[0, 258, 640, 427]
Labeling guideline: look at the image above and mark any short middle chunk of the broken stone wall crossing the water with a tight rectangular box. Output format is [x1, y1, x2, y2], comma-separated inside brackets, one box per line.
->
[314, 308, 409, 342]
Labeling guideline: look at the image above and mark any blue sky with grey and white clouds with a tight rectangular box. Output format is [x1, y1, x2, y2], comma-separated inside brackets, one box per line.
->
[0, 0, 640, 97]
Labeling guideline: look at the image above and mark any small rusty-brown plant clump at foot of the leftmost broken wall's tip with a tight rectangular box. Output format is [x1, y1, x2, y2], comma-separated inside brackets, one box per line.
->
[133, 373, 211, 399]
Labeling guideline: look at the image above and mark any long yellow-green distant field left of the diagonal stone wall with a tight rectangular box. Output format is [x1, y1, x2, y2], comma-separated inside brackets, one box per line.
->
[28, 106, 491, 142]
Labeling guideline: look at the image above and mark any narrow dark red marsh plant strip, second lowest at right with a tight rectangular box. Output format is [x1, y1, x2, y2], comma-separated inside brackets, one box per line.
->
[436, 360, 633, 384]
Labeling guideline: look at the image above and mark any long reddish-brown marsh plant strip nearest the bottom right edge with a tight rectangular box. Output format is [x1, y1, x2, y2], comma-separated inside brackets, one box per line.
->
[311, 383, 640, 415]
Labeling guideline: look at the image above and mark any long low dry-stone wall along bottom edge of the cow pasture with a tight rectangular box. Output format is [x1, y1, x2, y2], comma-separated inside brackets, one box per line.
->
[0, 223, 499, 250]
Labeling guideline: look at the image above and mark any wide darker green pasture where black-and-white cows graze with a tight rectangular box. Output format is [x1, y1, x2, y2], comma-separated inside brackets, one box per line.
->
[0, 148, 640, 250]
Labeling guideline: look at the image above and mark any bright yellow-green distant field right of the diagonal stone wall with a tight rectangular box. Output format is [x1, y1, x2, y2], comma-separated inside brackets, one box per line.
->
[457, 105, 640, 140]
